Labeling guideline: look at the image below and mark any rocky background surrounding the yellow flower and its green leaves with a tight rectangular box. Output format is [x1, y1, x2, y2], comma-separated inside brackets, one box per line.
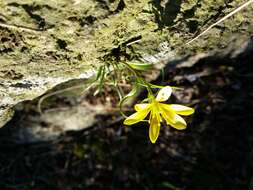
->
[0, 0, 253, 190]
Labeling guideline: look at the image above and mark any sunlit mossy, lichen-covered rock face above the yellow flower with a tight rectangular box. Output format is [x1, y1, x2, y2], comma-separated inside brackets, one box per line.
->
[0, 0, 253, 134]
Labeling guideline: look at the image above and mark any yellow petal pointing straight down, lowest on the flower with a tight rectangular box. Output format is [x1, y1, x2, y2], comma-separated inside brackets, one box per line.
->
[149, 115, 161, 143]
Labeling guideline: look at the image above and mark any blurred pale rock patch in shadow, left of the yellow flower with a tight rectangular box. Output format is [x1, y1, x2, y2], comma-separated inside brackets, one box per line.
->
[7, 100, 108, 144]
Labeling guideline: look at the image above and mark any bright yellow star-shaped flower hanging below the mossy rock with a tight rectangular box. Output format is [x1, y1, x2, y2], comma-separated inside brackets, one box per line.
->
[124, 86, 194, 143]
